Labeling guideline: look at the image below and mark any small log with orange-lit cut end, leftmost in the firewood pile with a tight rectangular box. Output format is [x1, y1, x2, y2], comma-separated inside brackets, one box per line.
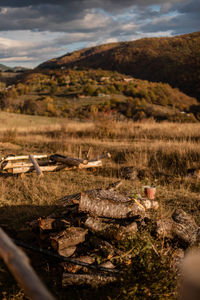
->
[39, 218, 70, 230]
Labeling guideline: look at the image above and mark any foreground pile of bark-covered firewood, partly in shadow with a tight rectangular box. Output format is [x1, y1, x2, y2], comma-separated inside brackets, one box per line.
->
[27, 182, 161, 287]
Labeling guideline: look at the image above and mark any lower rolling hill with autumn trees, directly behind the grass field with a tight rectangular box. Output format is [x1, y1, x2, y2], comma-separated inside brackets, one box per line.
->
[0, 68, 200, 122]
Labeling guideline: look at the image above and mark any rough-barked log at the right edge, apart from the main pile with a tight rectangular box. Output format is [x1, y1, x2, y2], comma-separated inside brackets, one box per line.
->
[172, 209, 199, 244]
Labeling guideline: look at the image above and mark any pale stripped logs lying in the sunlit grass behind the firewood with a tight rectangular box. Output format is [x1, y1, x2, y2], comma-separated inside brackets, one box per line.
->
[0, 153, 111, 176]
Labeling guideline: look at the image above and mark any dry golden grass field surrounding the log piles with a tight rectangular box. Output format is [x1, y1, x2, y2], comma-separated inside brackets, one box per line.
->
[0, 112, 200, 299]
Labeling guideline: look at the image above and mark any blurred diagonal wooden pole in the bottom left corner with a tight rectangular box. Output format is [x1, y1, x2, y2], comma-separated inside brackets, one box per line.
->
[0, 228, 54, 300]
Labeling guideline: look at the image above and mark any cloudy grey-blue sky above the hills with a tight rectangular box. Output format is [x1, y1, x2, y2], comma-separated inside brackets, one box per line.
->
[0, 0, 200, 67]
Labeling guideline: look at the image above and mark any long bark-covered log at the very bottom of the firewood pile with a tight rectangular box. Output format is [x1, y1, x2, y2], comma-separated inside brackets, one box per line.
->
[62, 273, 117, 287]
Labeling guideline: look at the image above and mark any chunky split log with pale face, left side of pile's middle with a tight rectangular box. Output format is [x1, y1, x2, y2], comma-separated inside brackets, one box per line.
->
[50, 227, 87, 255]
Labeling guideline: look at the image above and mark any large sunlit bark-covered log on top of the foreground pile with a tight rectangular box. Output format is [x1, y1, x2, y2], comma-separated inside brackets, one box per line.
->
[79, 190, 145, 219]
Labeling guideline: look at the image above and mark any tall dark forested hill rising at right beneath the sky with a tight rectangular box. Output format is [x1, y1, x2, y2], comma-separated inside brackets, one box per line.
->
[37, 32, 200, 100]
